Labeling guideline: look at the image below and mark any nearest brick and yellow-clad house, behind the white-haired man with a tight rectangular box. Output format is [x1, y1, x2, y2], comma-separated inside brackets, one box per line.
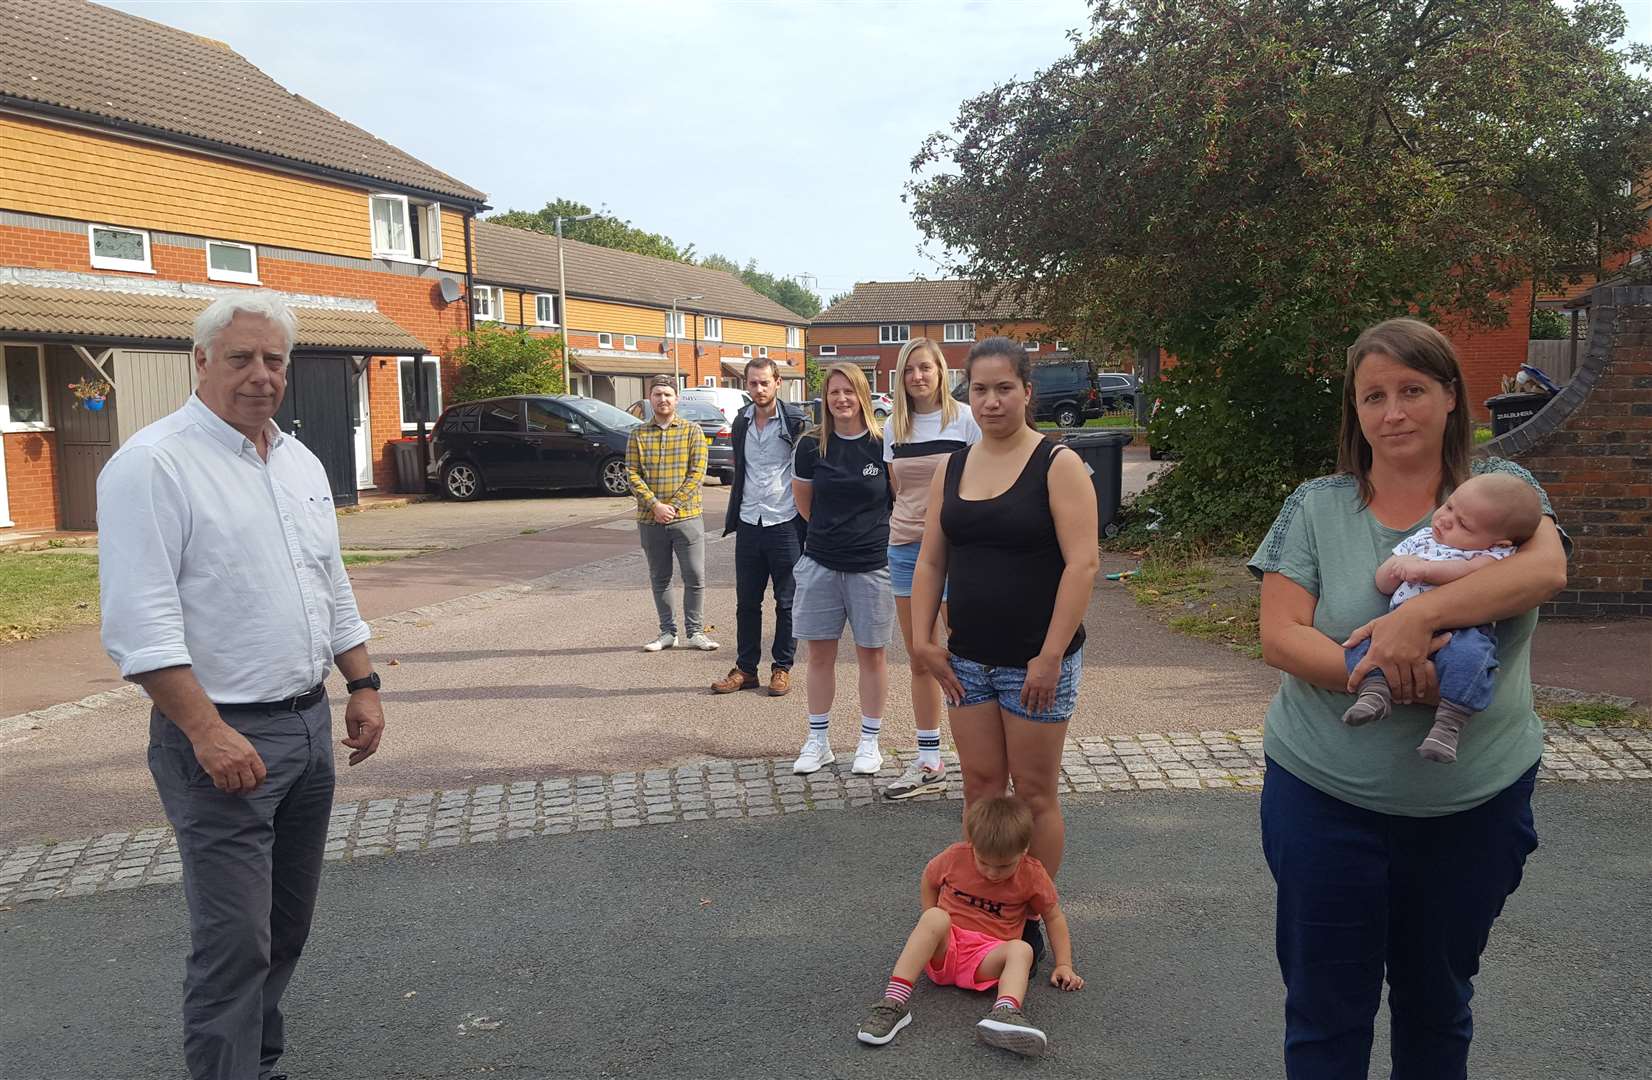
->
[0, 0, 486, 528]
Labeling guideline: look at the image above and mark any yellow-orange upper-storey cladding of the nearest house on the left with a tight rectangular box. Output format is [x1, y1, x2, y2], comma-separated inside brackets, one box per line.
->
[0, 116, 464, 272]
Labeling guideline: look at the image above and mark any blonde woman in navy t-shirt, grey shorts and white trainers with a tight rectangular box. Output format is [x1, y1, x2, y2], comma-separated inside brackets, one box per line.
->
[791, 363, 895, 776]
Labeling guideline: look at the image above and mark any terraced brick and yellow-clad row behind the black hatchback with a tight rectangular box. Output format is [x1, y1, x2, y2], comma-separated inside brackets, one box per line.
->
[471, 221, 809, 408]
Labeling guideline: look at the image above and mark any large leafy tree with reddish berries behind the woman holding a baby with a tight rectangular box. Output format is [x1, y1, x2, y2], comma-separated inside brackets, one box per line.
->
[909, 0, 1652, 547]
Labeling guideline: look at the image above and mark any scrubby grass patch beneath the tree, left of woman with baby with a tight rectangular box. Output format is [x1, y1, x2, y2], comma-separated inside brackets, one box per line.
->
[1125, 553, 1262, 659]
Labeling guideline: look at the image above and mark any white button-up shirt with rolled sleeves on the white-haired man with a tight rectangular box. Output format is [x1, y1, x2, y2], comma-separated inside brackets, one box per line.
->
[97, 395, 368, 705]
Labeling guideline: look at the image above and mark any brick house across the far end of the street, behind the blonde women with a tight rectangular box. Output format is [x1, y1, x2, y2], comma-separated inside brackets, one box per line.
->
[808, 279, 1072, 391]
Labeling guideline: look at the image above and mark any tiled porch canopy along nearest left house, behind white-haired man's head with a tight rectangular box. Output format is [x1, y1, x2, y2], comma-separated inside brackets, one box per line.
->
[0, 282, 430, 357]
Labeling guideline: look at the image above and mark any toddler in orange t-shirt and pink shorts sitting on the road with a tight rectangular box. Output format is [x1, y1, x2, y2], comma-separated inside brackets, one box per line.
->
[857, 796, 1084, 1057]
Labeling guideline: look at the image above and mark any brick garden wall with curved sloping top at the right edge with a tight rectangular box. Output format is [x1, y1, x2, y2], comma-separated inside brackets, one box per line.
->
[1483, 286, 1652, 618]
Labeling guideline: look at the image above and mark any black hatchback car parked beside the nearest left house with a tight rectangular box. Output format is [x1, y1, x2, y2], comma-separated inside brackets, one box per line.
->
[430, 395, 638, 500]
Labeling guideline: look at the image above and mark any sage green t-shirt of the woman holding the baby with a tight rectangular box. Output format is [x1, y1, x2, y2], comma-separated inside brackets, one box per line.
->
[1249, 457, 1553, 817]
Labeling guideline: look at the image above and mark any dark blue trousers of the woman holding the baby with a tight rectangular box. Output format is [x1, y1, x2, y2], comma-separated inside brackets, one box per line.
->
[1262, 760, 1538, 1080]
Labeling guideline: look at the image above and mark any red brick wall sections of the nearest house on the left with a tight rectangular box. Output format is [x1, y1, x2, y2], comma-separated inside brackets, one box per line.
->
[0, 226, 472, 502]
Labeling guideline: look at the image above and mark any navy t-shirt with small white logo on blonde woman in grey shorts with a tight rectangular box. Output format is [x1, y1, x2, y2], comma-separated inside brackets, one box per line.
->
[793, 433, 890, 573]
